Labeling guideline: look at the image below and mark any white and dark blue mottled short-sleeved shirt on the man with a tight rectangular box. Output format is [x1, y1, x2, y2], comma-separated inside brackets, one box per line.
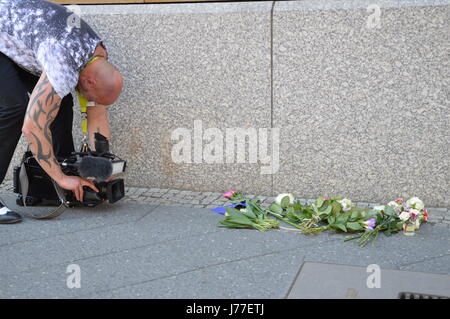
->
[0, 0, 102, 98]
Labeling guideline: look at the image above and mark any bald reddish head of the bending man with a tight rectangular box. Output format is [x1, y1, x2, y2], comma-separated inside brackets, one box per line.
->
[78, 58, 123, 105]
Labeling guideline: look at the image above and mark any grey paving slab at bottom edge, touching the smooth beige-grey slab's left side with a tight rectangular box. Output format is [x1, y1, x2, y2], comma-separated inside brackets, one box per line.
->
[89, 251, 303, 299]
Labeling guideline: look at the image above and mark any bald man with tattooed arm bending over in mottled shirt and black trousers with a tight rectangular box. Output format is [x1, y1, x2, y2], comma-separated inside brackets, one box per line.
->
[0, 0, 123, 224]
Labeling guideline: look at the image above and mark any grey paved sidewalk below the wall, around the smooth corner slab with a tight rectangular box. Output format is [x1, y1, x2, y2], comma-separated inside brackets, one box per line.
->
[0, 190, 450, 298]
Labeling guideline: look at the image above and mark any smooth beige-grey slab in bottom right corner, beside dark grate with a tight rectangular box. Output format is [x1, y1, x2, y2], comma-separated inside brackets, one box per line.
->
[288, 262, 450, 299]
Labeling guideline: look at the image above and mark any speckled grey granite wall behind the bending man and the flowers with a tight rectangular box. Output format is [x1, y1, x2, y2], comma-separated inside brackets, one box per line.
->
[5, 0, 450, 207]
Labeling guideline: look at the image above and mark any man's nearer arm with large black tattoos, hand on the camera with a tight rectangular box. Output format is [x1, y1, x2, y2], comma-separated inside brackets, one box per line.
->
[22, 72, 98, 201]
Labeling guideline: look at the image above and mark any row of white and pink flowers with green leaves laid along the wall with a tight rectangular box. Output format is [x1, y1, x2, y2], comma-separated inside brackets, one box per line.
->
[219, 191, 428, 246]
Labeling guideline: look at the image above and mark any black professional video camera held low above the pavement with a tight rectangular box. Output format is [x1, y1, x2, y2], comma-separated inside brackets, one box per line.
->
[13, 133, 126, 207]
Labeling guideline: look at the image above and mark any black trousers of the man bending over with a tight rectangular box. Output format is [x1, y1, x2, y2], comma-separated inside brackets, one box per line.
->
[0, 52, 75, 184]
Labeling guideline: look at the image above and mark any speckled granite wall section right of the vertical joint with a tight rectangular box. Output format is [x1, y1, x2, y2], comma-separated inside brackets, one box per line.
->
[273, 0, 450, 205]
